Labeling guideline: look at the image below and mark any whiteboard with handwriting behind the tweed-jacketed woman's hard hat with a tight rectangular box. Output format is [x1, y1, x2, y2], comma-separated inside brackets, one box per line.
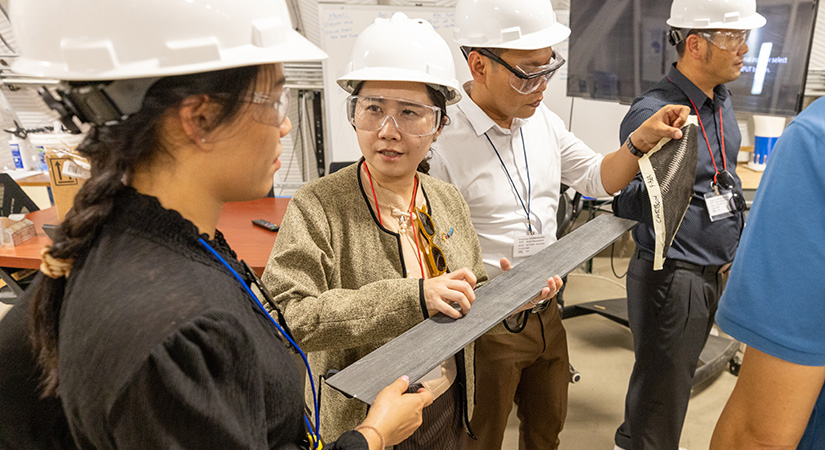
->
[318, 4, 471, 161]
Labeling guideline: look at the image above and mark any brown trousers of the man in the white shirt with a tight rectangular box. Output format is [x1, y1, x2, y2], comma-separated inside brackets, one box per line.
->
[466, 300, 570, 450]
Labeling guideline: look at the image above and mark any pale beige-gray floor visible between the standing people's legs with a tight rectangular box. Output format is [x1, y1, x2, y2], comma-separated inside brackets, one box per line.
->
[502, 258, 736, 450]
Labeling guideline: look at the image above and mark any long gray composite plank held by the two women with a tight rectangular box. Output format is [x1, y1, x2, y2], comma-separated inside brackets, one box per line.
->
[326, 215, 636, 404]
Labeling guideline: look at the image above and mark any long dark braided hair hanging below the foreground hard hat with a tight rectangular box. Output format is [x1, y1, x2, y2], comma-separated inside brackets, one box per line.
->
[29, 66, 265, 397]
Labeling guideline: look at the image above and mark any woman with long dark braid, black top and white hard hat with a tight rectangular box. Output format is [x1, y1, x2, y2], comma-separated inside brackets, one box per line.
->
[11, 0, 431, 450]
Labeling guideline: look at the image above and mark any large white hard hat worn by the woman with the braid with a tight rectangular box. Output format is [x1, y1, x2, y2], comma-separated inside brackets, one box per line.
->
[10, 0, 326, 81]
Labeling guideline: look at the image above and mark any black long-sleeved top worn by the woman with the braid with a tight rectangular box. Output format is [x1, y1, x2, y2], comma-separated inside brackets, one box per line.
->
[59, 188, 367, 449]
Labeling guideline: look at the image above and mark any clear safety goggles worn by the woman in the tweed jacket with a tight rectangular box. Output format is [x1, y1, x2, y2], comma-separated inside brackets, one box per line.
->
[347, 95, 442, 137]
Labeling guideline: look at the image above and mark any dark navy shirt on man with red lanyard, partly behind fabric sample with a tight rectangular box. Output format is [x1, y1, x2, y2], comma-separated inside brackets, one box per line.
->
[613, 64, 744, 266]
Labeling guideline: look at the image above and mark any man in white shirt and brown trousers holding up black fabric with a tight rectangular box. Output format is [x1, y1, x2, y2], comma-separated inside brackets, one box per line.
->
[431, 0, 688, 449]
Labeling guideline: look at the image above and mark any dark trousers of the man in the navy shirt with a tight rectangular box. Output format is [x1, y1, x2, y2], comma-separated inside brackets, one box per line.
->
[616, 250, 724, 450]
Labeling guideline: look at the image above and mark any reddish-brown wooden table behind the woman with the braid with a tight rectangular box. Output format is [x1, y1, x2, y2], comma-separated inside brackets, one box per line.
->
[0, 198, 289, 275]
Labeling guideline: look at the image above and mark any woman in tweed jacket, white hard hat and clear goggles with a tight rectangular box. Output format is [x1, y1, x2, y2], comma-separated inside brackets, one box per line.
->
[263, 13, 561, 450]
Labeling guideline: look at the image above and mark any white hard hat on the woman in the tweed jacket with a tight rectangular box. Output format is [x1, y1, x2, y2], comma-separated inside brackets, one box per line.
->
[338, 12, 461, 105]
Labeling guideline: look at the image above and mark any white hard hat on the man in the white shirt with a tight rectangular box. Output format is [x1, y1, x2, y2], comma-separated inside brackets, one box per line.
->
[455, 0, 570, 50]
